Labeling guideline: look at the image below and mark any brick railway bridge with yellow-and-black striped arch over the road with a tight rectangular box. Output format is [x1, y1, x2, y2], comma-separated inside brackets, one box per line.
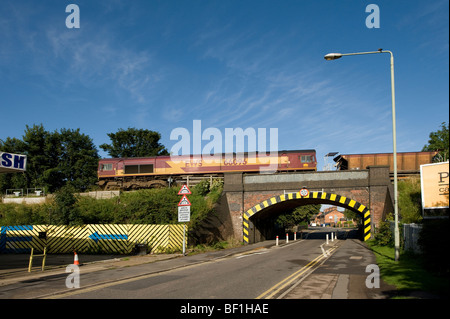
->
[207, 166, 394, 243]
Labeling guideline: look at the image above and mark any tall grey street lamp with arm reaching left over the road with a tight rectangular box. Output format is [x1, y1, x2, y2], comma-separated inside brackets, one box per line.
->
[324, 49, 400, 261]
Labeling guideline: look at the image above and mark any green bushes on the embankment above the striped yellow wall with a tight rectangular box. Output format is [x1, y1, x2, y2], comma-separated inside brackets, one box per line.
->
[0, 182, 222, 229]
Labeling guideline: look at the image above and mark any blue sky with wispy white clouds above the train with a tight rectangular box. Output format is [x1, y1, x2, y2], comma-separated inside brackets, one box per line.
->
[0, 0, 449, 169]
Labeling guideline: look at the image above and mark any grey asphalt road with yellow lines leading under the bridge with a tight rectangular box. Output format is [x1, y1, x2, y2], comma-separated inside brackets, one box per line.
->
[0, 229, 394, 299]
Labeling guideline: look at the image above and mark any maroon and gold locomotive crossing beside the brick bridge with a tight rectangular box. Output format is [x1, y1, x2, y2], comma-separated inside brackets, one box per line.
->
[98, 150, 317, 190]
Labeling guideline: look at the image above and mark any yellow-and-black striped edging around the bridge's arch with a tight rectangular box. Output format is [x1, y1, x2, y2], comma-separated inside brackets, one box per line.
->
[242, 192, 371, 244]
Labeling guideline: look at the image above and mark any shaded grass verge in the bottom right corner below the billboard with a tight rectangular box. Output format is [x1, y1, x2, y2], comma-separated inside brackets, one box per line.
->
[368, 242, 449, 298]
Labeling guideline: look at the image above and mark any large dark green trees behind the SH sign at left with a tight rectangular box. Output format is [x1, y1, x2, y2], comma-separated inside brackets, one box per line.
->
[0, 124, 99, 193]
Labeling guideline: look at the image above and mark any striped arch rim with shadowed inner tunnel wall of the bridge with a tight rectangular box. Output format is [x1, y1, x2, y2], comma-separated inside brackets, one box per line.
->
[243, 192, 371, 243]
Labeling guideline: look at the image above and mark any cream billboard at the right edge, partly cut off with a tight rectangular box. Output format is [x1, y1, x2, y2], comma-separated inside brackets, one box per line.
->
[420, 162, 449, 218]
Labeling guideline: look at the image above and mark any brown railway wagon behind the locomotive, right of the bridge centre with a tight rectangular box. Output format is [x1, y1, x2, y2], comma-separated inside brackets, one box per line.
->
[333, 151, 438, 173]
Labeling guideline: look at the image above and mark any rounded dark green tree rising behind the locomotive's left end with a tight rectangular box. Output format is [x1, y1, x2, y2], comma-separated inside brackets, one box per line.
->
[100, 128, 169, 157]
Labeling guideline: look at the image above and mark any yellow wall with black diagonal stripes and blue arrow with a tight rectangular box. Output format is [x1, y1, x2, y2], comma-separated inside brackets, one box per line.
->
[0, 224, 183, 254]
